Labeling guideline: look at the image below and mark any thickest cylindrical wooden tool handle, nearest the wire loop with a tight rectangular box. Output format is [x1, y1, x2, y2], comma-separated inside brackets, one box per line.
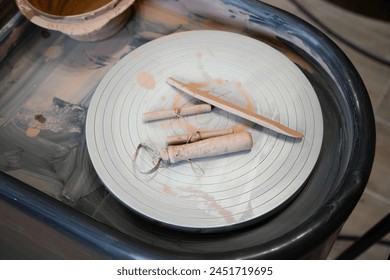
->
[160, 132, 253, 163]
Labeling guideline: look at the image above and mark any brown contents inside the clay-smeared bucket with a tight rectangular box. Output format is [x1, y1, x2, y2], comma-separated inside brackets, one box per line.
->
[28, 0, 112, 16]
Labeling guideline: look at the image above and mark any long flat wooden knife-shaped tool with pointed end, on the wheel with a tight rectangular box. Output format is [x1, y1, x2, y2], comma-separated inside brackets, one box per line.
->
[167, 77, 303, 138]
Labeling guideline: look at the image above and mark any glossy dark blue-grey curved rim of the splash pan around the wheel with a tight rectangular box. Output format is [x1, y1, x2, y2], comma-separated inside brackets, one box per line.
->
[0, 0, 375, 259]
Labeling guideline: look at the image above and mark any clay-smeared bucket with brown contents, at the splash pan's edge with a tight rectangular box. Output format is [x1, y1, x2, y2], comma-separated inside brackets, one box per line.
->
[16, 0, 134, 41]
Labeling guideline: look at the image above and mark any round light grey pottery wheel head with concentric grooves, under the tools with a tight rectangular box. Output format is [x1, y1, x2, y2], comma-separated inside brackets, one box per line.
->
[86, 31, 323, 231]
